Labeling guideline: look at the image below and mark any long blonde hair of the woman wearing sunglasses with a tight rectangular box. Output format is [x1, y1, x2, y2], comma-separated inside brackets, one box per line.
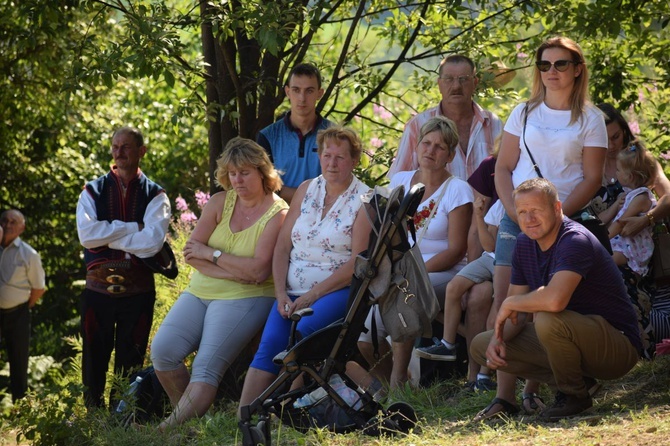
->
[528, 36, 589, 124]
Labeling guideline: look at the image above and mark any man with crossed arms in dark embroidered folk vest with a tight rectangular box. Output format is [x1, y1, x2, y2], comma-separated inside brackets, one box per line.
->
[77, 127, 171, 408]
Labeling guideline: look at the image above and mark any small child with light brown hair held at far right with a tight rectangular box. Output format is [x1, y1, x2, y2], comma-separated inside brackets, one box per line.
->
[603, 140, 656, 276]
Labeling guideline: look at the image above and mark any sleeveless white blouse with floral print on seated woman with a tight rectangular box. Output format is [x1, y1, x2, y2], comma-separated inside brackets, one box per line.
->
[286, 175, 370, 296]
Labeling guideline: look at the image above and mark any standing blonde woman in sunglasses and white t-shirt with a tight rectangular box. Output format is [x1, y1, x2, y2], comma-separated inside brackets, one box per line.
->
[476, 37, 607, 419]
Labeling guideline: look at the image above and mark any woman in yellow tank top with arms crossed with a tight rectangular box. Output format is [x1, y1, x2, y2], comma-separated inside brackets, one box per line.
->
[151, 138, 288, 430]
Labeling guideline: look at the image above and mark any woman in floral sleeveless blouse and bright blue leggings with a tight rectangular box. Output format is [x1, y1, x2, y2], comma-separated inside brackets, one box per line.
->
[240, 126, 371, 407]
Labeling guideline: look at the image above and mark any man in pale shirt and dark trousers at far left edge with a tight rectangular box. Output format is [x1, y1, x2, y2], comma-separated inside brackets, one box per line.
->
[0, 209, 45, 401]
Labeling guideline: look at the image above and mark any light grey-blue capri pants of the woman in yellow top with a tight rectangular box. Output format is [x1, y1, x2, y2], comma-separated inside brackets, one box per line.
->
[151, 292, 276, 387]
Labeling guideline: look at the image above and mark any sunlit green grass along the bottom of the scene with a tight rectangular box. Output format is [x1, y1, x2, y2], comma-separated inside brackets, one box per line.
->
[0, 356, 670, 446]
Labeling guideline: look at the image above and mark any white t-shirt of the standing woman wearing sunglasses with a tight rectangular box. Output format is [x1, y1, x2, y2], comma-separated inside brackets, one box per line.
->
[505, 103, 608, 201]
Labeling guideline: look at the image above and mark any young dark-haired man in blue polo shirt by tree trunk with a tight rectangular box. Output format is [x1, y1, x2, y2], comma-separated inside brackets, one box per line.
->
[256, 63, 332, 204]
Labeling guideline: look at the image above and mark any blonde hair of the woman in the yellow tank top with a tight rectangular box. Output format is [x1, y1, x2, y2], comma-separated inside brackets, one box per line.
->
[214, 137, 283, 194]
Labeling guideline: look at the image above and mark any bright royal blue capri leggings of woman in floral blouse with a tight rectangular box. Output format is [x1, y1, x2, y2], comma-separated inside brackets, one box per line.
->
[251, 287, 349, 375]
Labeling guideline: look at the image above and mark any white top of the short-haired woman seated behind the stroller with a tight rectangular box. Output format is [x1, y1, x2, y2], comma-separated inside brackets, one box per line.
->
[390, 170, 474, 269]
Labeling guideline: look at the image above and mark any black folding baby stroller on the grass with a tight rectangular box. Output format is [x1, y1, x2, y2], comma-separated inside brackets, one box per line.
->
[239, 184, 424, 446]
